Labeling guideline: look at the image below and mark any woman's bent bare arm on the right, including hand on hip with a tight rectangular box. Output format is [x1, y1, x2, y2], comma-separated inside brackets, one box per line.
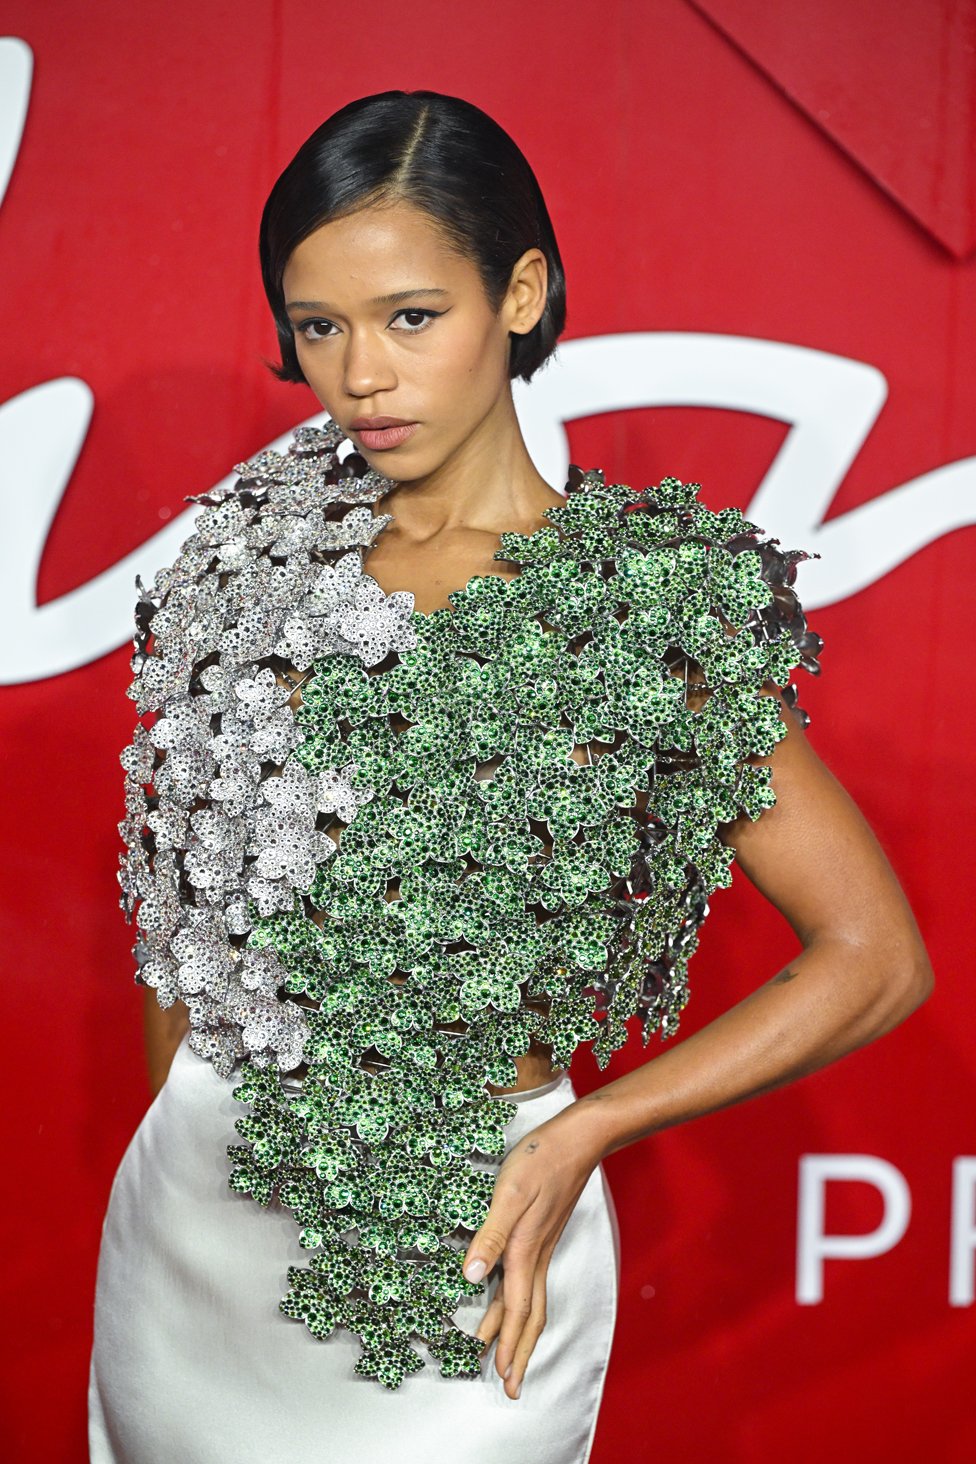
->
[464, 682, 932, 1398]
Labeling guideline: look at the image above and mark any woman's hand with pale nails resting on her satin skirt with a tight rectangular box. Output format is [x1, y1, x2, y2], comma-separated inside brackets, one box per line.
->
[462, 1105, 600, 1398]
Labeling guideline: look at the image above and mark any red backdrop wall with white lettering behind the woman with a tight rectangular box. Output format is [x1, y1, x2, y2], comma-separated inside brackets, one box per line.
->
[0, 0, 976, 1464]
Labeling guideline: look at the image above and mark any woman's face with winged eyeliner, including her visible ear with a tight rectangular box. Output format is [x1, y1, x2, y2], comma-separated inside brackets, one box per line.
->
[282, 202, 546, 482]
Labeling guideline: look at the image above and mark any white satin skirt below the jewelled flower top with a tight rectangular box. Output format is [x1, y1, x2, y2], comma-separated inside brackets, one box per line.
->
[88, 1038, 620, 1464]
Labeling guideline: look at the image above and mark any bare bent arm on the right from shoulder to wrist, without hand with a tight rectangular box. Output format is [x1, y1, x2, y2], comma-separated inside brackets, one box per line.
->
[572, 690, 934, 1158]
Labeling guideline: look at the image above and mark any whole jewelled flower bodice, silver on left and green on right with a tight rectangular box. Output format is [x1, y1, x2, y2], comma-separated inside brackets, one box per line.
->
[120, 425, 821, 1388]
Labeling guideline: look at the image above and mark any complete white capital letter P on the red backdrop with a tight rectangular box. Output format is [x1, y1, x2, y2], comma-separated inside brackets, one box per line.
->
[796, 1154, 913, 1306]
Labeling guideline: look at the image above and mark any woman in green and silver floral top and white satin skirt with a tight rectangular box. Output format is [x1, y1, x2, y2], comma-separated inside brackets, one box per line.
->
[91, 92, 932, 1464]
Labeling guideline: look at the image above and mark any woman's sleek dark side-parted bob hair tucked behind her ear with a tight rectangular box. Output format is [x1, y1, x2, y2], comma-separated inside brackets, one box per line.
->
[260, 91, 566, 382]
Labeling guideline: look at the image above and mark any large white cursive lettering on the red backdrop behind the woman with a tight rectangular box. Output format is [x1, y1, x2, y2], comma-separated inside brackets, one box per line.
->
[0, 38, 976, 685]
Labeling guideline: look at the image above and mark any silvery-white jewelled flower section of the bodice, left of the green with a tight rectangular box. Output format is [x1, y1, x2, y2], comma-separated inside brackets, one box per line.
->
[120, 425, 416, 1075]
